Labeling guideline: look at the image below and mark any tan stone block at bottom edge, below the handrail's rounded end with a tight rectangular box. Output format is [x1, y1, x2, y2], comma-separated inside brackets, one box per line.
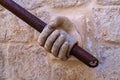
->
[52, 61, 95, 80]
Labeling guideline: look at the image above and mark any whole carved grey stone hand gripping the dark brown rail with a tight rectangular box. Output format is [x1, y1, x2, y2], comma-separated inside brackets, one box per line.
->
[38, 16, 77, 60]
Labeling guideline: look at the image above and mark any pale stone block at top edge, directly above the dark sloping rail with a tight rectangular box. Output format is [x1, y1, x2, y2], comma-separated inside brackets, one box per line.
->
[13, 0, 46, 10]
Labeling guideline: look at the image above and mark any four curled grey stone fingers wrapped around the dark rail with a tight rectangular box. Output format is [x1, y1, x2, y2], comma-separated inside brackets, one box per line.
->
[38, 25, 76, 60]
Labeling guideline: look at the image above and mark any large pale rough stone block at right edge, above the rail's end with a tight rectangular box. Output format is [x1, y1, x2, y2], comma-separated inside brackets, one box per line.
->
[93, 7, 120, 43]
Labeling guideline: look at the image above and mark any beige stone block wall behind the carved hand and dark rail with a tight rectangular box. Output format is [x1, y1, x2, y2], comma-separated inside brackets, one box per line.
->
[0, 0, 120, 80]
